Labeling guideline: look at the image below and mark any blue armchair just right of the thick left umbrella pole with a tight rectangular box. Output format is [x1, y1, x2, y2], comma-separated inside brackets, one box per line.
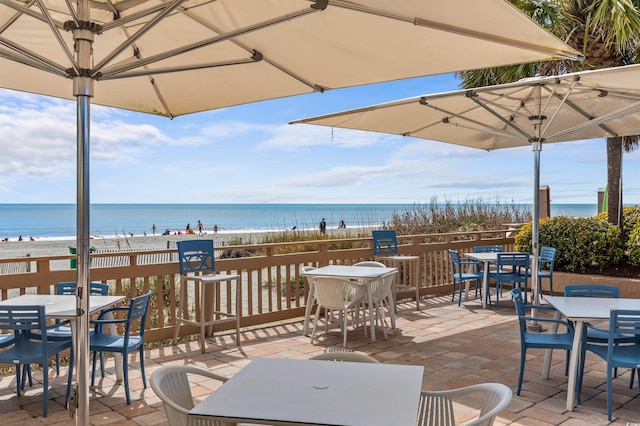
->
[89, 291, 151, 405]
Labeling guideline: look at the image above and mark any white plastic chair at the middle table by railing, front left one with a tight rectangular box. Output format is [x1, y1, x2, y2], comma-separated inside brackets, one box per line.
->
[311, 276, 367, 348]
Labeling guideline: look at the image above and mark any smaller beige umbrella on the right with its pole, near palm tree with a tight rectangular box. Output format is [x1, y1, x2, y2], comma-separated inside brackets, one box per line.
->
[293, 65, 640, 314]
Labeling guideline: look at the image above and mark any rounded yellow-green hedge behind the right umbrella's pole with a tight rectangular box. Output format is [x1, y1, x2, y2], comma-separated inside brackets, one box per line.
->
[515, 216, 623, 272]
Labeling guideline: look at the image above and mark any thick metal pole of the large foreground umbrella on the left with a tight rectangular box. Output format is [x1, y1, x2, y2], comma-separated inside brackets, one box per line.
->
[69, 0, 94, 426]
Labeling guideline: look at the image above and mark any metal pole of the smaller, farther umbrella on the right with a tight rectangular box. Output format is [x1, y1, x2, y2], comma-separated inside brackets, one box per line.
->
[527, 140, 542, 331]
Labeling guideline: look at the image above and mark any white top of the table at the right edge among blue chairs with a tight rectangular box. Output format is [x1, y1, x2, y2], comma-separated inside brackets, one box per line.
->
[544, 296, 640, 321]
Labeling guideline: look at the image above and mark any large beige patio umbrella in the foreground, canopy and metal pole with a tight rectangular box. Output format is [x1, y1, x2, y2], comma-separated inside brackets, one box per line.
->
[0, 0, 580, 424]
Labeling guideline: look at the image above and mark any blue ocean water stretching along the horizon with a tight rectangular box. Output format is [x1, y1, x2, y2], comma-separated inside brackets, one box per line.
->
[0, 204, 597, 240]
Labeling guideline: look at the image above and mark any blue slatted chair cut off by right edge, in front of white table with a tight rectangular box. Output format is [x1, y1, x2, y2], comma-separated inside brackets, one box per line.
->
[578, 309, 640, 421]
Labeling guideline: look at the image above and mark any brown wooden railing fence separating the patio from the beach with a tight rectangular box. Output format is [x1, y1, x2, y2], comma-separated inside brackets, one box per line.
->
[0, 229, 514, 341]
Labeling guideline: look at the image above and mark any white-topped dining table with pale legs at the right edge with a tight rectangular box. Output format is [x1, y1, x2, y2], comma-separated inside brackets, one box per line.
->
[542, 296, 640, 411]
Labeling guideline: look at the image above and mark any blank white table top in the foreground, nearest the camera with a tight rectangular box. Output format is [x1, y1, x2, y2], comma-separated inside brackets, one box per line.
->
[190, 358, 424, 426]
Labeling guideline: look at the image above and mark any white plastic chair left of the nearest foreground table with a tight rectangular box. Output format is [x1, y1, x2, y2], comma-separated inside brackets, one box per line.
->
[149, 365, 227, 426]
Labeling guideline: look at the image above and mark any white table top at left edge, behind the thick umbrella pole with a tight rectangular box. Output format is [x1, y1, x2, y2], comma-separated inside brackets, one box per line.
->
[0, 294, 124, 319]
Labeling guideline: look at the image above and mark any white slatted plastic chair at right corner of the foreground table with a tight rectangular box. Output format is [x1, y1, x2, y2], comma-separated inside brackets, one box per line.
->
[417, 383, 513, 426]
